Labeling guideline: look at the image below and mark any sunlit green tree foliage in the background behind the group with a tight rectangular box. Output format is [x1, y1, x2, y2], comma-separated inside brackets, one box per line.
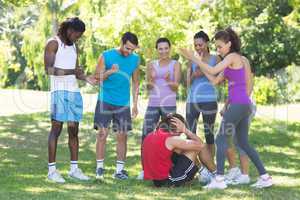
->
[0, 0, 300, 102]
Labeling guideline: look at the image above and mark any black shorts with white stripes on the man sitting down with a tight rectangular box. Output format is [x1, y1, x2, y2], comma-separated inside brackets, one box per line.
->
[153, 153, 198, 187]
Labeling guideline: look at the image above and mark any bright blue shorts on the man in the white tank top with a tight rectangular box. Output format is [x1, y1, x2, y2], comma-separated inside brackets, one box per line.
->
[51, 90, 83, 122]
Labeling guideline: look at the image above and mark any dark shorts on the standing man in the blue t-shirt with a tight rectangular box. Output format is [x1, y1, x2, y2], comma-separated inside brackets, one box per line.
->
[94, 101, 132, 132]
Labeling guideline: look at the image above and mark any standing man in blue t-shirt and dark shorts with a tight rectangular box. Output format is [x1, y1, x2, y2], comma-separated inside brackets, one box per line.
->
[94, 32, 140, 179]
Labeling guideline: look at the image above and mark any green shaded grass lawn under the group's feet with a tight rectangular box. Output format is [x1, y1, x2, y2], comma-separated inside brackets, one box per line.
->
[0, 113, 300, 200]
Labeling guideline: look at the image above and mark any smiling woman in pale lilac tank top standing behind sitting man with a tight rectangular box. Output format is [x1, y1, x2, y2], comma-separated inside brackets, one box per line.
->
[139, 38, 180, 179]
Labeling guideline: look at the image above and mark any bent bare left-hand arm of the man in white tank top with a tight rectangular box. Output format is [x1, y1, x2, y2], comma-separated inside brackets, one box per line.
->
[44, 39, 75, 76]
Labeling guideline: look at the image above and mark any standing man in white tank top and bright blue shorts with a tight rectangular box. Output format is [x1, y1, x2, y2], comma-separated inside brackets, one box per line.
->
[44, 17, 96, 183]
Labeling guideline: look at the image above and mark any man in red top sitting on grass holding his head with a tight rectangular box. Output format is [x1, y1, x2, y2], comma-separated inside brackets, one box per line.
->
[142, 114, 216, 187]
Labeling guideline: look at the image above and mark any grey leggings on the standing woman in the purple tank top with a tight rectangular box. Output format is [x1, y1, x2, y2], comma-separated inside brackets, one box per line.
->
[216, 104, 266, 175]
